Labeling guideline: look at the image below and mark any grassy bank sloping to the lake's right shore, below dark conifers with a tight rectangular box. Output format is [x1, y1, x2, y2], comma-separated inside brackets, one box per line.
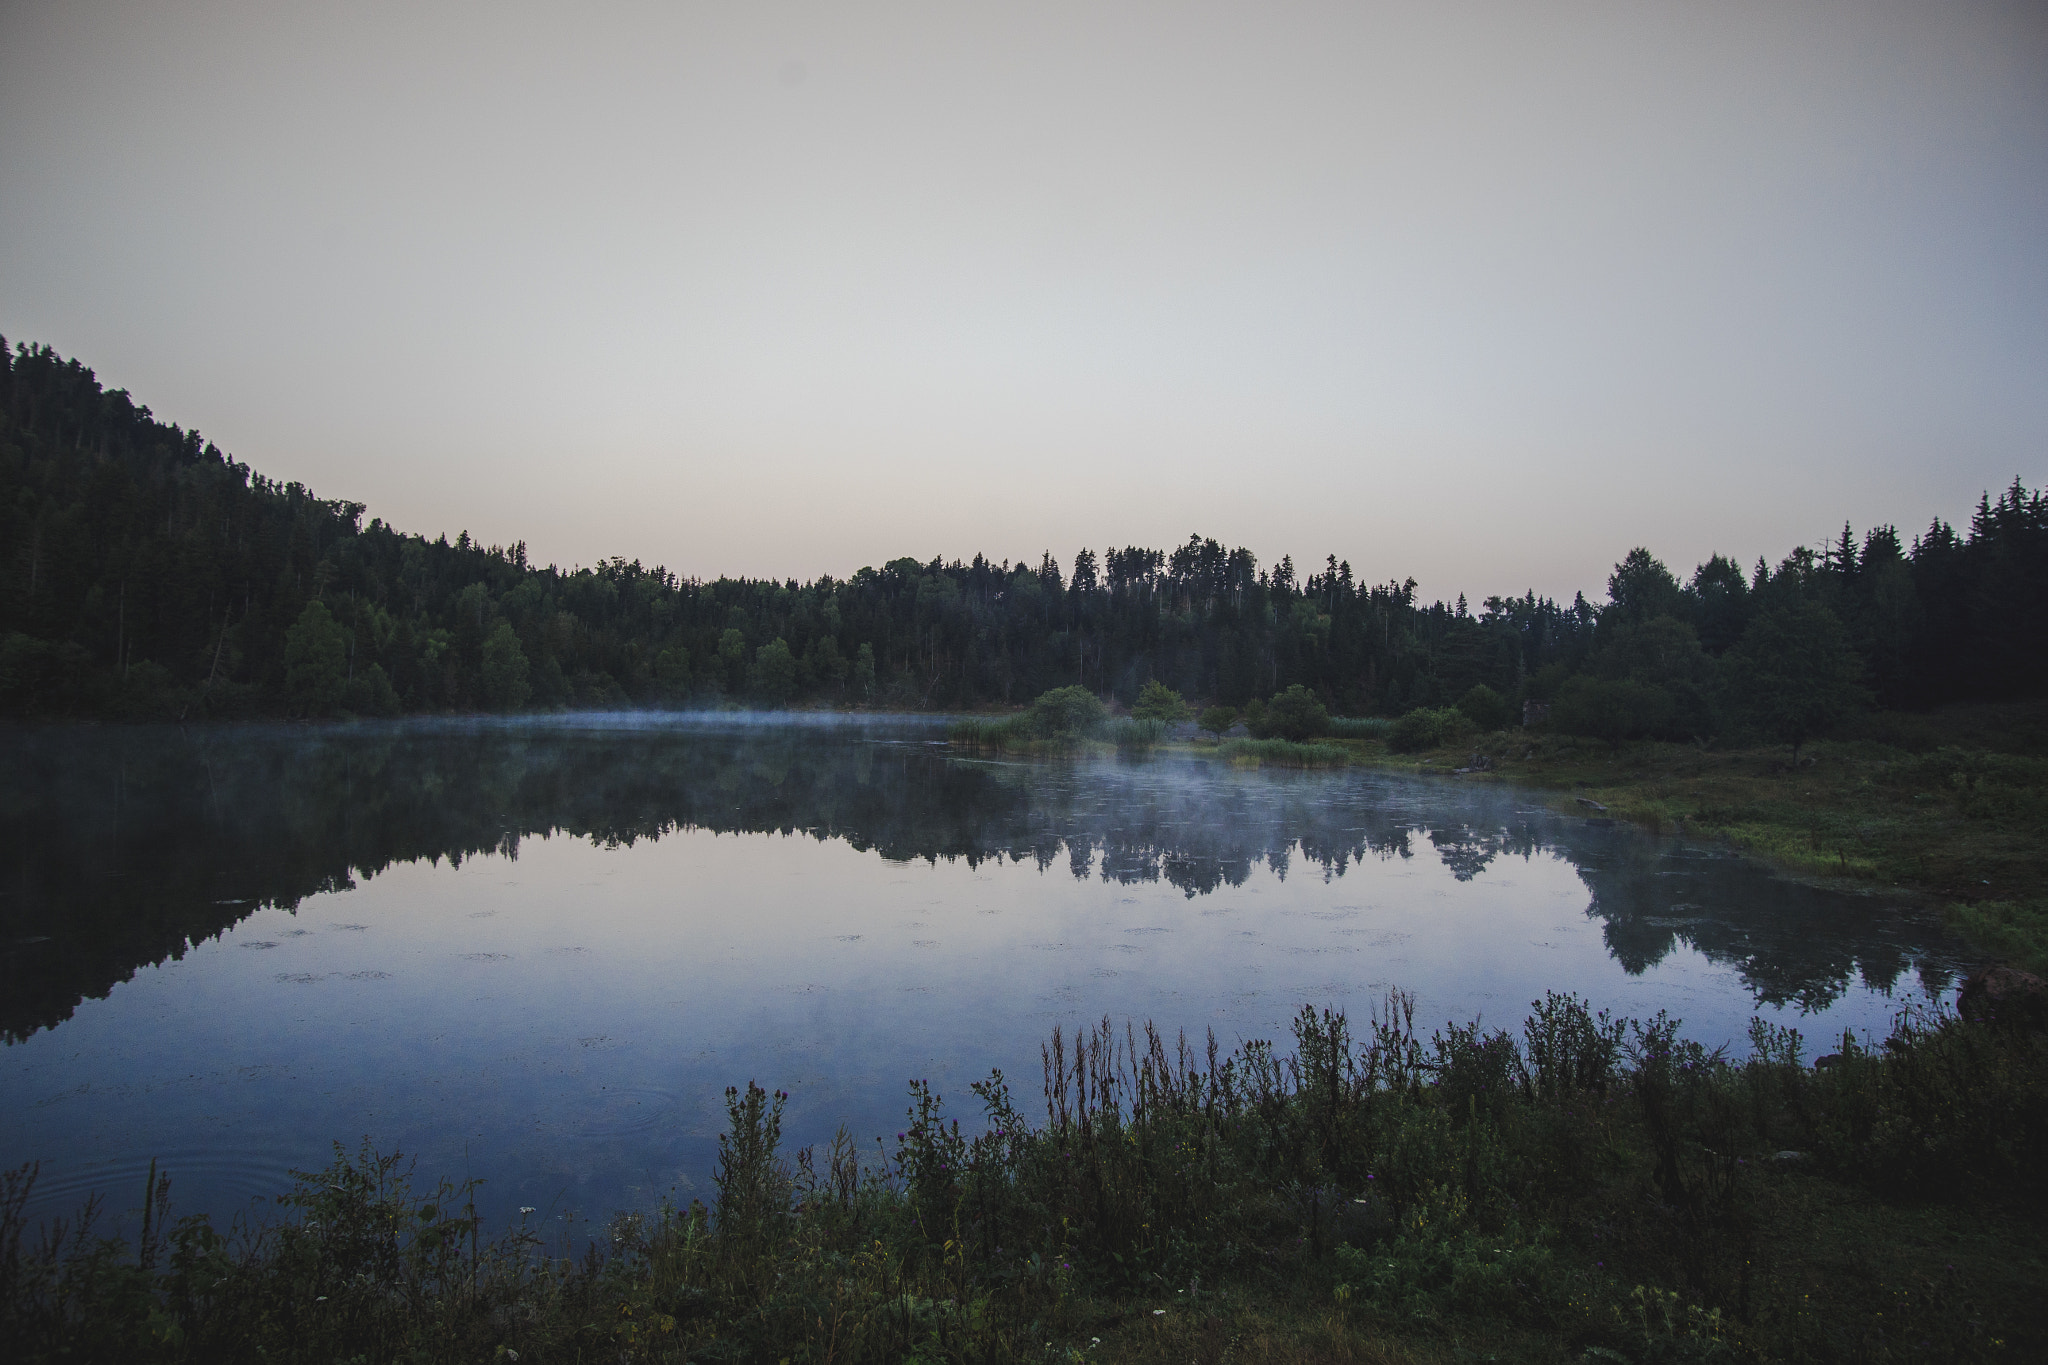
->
[1348, 702, 2048, 972]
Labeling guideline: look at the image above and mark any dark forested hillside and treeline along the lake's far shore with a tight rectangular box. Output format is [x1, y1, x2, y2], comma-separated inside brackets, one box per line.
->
[0, 342, 2048, 737]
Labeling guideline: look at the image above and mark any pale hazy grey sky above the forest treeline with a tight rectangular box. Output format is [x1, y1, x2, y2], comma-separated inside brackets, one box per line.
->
[0, 0, 2048, 598]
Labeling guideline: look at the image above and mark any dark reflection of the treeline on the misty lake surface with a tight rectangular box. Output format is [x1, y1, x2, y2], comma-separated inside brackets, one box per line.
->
[0, 716, 1954, 1040]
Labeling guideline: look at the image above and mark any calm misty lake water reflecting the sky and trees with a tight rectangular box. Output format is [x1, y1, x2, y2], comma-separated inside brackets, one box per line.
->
[0, 716, 1958, 1218]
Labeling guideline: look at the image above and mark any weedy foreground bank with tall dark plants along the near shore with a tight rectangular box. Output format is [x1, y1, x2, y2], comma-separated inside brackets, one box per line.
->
[0, 995, 2048, 1363]
